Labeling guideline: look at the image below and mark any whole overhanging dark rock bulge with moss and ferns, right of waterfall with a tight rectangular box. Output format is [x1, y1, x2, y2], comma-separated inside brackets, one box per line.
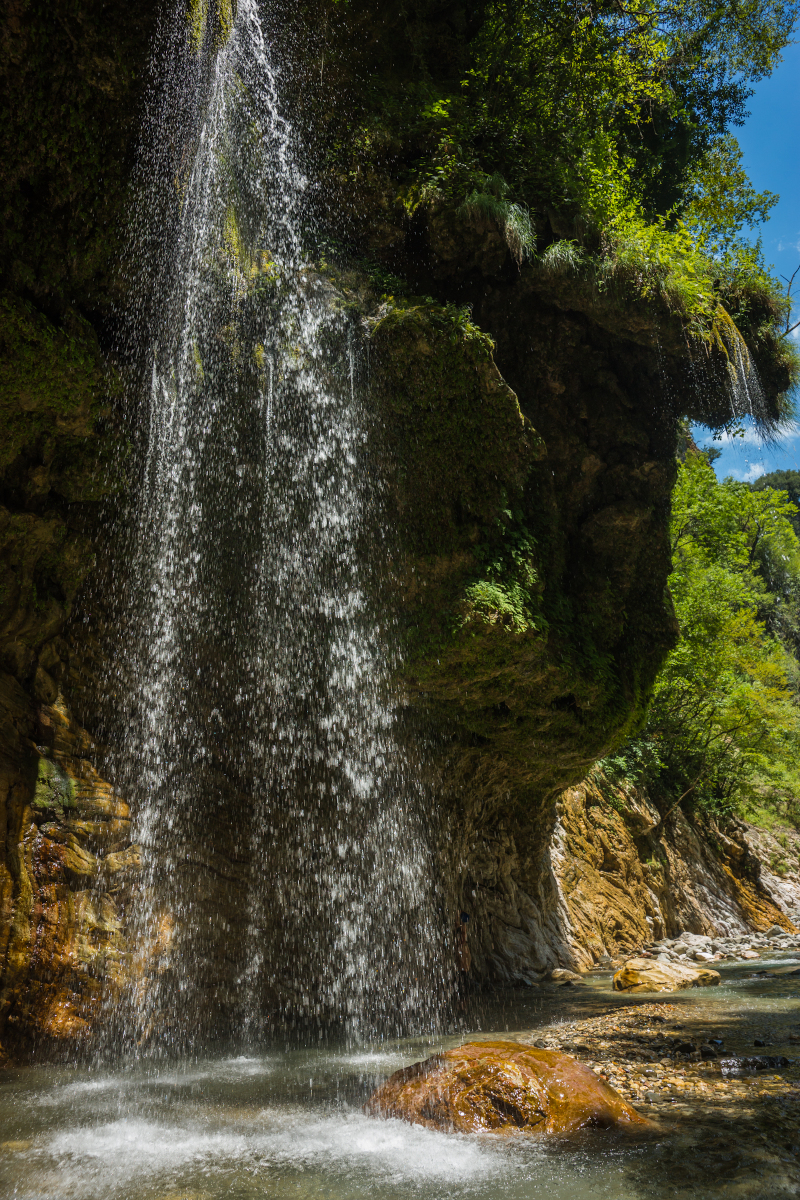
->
[372, 272, 676, 799]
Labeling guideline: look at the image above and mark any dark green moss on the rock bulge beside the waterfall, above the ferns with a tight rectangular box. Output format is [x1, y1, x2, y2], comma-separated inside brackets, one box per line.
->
[371, 302, 543, 557]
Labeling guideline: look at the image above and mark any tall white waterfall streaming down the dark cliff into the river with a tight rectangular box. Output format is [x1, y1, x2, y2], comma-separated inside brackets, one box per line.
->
[115, 0, 449, 1049]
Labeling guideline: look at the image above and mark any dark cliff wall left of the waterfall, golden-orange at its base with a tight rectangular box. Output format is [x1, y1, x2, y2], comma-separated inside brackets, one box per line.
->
[0, 0, 157, 1048]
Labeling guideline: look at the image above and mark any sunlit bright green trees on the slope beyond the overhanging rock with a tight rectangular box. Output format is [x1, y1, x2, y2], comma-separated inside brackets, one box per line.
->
[610, 452, 800, 810]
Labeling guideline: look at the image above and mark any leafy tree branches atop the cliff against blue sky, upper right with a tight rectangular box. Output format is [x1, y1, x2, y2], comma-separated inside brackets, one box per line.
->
[330, 0, 798, 221]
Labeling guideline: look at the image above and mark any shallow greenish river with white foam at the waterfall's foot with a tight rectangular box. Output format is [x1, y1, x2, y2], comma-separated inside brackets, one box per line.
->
[0, 956, 800, 1200]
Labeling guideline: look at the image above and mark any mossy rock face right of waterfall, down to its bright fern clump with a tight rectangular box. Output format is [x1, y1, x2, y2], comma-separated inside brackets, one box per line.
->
[372, 301, 551, 661]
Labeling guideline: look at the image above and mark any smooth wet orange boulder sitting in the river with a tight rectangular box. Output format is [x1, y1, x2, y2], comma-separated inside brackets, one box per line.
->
[365, 1042, 650, 1134]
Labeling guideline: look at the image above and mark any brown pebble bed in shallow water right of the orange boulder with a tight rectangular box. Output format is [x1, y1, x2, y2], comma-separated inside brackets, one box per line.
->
[506, 1001, 800, 1200]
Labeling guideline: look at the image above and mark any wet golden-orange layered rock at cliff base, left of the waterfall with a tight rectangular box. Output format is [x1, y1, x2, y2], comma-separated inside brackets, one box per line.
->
[0, 696, 139, 1051]
